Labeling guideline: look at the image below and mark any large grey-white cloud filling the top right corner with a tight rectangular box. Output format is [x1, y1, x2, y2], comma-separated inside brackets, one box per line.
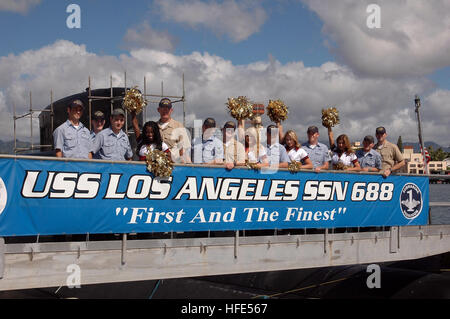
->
[302, 0, 450, 77]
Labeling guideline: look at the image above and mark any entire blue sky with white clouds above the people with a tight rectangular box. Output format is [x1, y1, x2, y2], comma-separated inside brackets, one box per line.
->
[0, 0, 450, 146]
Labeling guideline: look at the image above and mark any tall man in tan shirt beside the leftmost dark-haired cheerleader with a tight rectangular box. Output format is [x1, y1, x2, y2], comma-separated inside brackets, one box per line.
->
[158, 98, 191, 163]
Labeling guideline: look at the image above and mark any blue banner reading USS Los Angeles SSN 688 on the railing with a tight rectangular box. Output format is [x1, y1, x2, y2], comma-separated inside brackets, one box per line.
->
[0, 157, 429, 236]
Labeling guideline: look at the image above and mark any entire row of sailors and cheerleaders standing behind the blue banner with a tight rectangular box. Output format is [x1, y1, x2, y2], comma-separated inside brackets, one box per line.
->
[53, 98, 405, 177]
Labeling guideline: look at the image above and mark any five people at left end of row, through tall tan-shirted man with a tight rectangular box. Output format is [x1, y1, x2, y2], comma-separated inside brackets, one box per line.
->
[53, 99, 187, 162]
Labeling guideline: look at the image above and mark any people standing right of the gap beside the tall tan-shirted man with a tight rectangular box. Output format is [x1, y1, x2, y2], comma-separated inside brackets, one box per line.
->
[188, 114, 405, 177]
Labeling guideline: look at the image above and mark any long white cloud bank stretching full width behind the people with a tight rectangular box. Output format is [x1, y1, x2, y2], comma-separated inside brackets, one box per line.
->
[0, 41, 450, 148]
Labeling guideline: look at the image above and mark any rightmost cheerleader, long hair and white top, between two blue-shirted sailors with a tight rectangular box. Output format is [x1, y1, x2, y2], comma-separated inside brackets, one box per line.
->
[331, 134, 361, 171]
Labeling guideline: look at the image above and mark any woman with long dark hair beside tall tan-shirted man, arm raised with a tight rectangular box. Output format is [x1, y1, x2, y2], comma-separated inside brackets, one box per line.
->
[131, 112, 171, 161]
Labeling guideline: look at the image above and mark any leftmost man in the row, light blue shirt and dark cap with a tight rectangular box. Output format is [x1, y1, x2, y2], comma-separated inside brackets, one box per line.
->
[53, 100, 92, 159]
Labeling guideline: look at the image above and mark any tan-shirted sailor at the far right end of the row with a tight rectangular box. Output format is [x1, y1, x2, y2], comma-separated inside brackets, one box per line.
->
[374, 126, 405, 177]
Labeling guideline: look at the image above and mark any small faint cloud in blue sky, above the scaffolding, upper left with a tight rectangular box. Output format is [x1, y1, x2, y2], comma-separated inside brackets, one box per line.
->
[123, 22, 177, 52]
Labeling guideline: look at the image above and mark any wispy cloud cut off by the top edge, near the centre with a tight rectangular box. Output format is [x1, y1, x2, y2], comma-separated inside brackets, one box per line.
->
[156, 0, 267, 42]
